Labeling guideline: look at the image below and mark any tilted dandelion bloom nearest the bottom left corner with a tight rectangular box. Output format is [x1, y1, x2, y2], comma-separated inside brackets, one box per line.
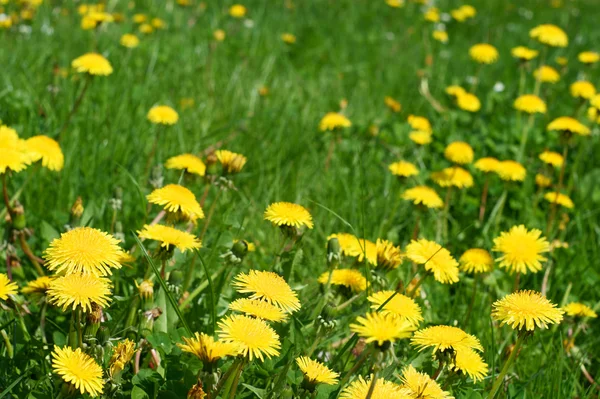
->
[52, 345, 104, 398]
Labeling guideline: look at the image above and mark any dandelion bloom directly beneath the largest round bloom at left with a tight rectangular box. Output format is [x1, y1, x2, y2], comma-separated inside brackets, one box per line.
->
[47, 274, 110, 312]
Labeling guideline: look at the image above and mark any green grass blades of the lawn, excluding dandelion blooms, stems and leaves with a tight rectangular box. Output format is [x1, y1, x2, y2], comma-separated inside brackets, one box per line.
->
[0, 0, 600, 398]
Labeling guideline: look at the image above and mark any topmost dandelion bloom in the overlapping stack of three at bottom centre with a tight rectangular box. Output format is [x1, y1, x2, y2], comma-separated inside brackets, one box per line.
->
[233, 270, 300, 313]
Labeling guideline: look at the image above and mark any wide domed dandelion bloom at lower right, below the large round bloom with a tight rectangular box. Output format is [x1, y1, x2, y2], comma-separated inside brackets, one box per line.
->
[492, 290, 564, 331]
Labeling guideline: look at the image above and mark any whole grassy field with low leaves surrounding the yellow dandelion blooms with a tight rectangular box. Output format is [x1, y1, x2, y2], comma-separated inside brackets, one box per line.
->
[0, 0, 600, 399]
